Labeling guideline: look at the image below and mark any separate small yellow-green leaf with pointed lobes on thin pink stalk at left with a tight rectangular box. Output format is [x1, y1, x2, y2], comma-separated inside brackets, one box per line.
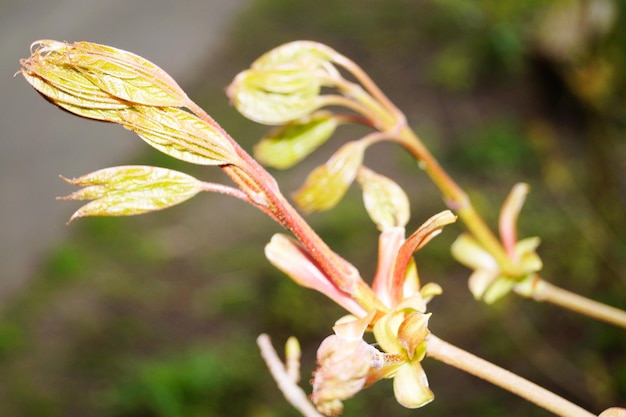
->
[60, 166, 202, 222]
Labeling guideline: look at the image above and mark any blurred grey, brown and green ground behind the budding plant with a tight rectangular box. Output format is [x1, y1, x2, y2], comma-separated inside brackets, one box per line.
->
[0, 0, 626, 417]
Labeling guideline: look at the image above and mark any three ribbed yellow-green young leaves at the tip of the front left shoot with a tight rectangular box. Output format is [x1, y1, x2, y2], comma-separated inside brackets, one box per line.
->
[21, 40, 245, 221]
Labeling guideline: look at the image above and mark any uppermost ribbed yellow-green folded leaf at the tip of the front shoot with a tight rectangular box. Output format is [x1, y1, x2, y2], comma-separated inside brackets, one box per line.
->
[20, 40, 188, 111]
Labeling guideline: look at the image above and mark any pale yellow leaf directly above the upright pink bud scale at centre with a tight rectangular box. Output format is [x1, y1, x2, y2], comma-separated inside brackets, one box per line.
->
[357, 167, 411, 231]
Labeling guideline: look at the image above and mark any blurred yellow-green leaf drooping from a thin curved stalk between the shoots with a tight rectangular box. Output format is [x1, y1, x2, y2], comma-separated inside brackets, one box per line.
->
[294, 141, 367, 213]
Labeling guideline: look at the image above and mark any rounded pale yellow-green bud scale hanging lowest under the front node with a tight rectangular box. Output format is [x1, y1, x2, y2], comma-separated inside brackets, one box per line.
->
[393, 360, 435, 408]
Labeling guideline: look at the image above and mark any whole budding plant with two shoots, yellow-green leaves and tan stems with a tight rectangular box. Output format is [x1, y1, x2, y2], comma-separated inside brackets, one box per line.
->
[21, 40, 626, 417]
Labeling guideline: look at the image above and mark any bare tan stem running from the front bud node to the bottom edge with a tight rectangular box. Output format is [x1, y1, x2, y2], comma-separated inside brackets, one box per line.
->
[426, 334, 595, 417]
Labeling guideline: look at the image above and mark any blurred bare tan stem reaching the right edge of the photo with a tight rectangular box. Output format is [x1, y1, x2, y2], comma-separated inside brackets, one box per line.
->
[515, 277, 626, 328]
